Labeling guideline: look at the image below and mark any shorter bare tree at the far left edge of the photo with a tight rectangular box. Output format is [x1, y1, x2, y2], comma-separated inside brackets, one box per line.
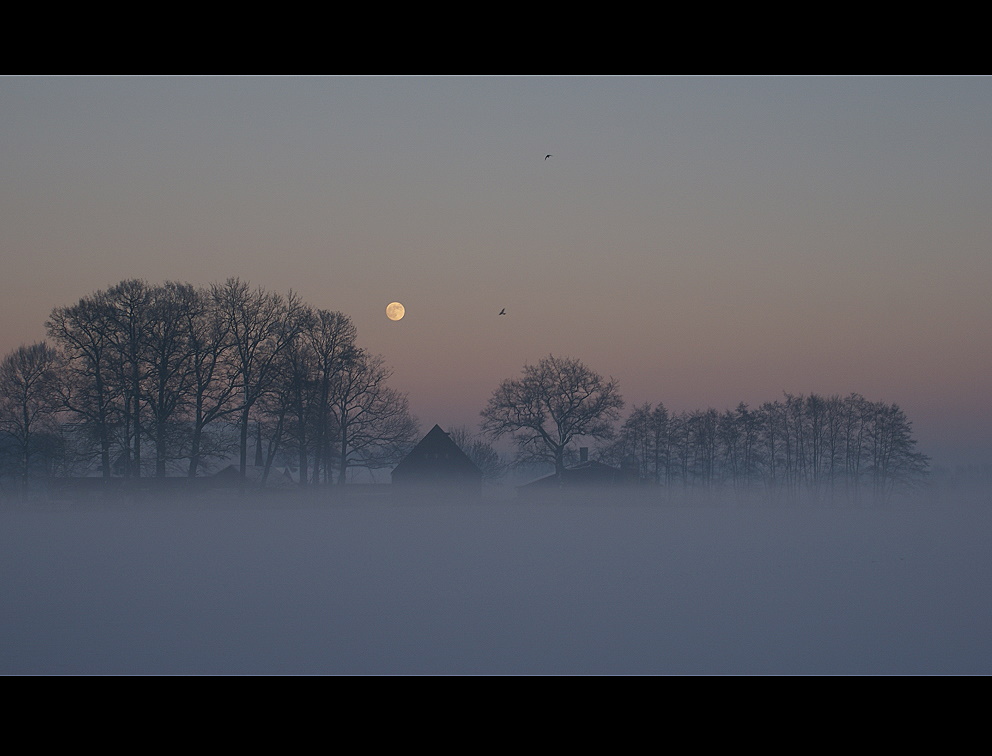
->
[0, 341, 62, 489]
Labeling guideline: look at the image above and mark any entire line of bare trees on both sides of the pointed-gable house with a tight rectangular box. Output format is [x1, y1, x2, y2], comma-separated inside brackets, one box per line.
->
[0, 278, 929, 500]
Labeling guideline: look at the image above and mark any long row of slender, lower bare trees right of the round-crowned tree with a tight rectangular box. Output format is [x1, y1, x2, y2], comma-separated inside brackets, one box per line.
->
[601, 393, 929, 500]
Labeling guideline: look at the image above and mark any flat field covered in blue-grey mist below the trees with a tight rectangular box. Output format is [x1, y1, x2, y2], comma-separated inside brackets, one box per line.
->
[0, 491, 992, 675]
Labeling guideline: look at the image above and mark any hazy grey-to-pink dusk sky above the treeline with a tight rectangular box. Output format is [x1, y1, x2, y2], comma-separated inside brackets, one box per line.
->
[0, 77, 992, 462]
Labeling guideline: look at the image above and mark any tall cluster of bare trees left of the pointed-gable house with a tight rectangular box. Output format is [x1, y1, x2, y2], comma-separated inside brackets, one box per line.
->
[0, 278, 418, 486]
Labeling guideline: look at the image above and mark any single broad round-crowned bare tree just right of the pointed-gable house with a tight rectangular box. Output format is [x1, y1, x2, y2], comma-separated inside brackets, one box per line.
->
[480, 355, 623, 479]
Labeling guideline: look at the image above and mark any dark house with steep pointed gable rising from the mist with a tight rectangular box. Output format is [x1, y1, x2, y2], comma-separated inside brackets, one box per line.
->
[392, 425, 482, 493]
